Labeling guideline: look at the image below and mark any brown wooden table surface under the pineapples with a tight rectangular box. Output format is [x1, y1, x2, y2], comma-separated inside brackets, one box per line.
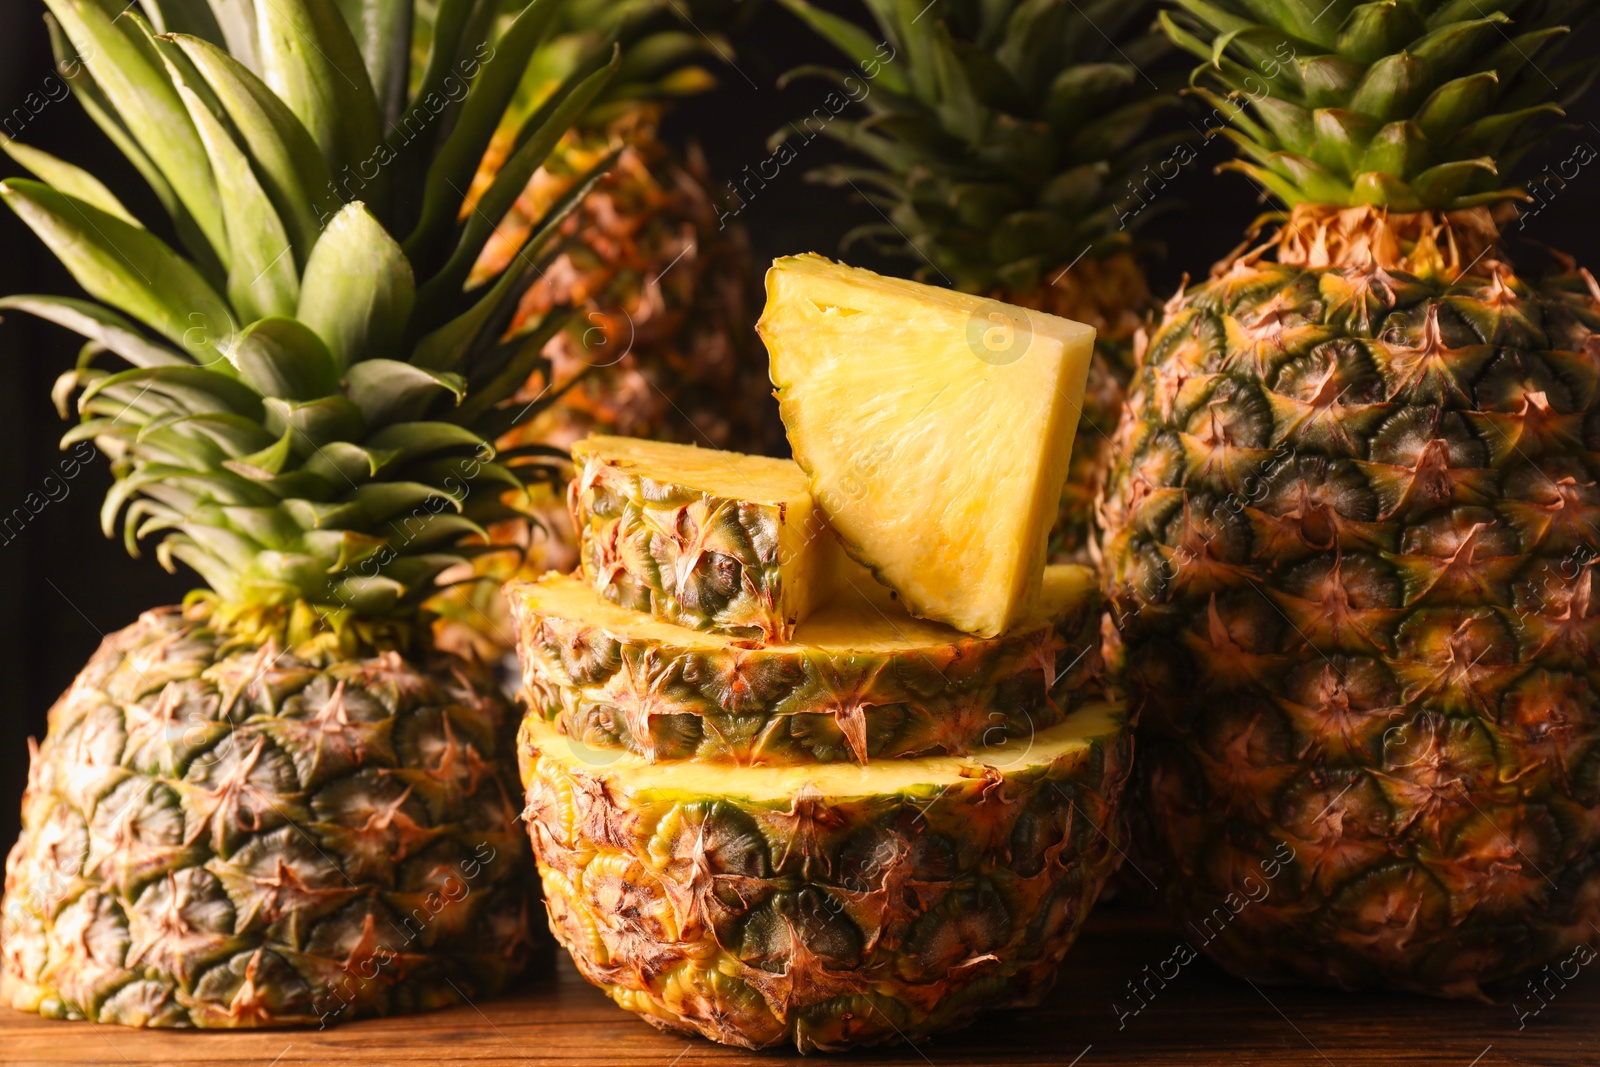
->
[0, 907, 1600, 1067]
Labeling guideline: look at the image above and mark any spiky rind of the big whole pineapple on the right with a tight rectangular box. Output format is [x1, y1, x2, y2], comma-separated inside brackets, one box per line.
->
[1102, 256, 1600, 995]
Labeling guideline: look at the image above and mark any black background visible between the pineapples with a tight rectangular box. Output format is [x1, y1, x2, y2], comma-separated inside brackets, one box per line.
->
[0, 0, 1600, 849]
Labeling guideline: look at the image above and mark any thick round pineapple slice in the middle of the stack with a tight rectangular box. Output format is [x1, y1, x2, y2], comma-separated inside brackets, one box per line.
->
[507, 566, 1101, 765]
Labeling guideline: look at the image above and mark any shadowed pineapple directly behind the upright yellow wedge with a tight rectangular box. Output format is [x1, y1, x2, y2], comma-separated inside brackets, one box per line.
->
[782, 0, 1176, 563]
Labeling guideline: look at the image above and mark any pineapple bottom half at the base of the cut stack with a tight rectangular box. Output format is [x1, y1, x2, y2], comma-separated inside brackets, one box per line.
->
[518, 704, 1130, 1051]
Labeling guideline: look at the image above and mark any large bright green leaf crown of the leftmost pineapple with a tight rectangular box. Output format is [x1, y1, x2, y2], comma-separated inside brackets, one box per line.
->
[0, 0, 619, 619]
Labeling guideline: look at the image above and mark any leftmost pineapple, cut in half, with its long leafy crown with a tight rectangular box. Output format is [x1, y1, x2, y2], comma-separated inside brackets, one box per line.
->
[0, 0, 614, 1027]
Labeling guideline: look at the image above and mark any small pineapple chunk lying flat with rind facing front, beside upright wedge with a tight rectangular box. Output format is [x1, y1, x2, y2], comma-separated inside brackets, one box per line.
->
[570, 435, 848, 645]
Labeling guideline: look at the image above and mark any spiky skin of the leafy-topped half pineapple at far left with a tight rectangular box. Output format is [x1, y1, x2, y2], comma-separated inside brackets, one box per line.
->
[0, 608, 531, 1027]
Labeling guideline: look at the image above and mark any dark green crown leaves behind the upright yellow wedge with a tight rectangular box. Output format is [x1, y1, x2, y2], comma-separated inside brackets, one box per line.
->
[773, 0, 1187, 291]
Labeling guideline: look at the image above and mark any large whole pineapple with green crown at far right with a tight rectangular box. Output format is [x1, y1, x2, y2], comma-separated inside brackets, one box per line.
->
[1102, 0, 1600, 997]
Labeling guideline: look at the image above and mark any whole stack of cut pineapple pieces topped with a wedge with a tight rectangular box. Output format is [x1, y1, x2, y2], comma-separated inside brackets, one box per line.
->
[507, 258, 1131, 1051]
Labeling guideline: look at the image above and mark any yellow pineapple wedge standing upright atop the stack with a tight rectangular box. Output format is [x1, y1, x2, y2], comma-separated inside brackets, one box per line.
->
[757, 254, 1094, 637]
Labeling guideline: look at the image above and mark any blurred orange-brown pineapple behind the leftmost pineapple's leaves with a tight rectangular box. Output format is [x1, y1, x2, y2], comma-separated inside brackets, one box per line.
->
[421, 0, 781, 659]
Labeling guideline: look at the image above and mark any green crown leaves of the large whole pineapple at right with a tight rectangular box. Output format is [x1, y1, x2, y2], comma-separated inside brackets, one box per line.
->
[1162, 0, 1597, 211]
